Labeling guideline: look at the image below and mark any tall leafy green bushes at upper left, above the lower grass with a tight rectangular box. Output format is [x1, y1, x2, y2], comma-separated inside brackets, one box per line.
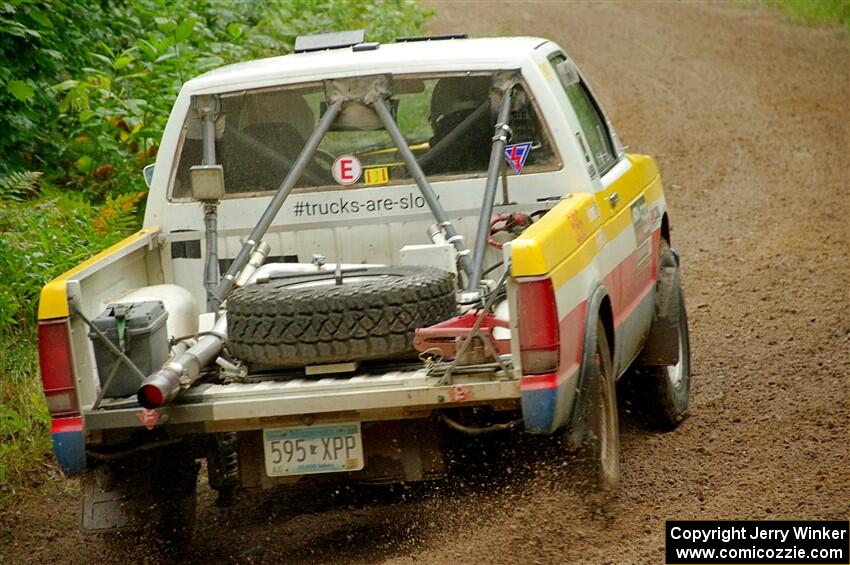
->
[0, 0, 429, 198]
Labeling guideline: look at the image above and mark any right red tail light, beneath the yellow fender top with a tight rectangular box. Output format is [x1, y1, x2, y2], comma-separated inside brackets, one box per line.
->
[517, 277, 561, 375]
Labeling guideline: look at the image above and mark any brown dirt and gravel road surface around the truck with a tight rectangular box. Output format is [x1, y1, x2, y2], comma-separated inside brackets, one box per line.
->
[0, 2, 850, 564]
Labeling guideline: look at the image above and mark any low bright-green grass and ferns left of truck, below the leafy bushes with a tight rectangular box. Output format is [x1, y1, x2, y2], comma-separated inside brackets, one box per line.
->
[0, 183, 142, 508]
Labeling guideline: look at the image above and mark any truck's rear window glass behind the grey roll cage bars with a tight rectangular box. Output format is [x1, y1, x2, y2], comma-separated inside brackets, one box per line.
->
[171, 73, 560, 200]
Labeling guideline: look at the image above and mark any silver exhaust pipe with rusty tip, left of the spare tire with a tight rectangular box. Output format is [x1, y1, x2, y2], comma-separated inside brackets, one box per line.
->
[136, 314, 227, 409]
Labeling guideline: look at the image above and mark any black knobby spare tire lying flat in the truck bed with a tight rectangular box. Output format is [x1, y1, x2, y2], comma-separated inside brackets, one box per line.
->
[227, 267, 450, 367]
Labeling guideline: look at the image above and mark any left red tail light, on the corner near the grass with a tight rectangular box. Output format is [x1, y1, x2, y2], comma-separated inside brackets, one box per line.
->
[38, 318, 80, 418]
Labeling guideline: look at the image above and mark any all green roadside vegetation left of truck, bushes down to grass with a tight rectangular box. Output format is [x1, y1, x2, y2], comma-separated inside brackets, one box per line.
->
[0, 0, 430, 500]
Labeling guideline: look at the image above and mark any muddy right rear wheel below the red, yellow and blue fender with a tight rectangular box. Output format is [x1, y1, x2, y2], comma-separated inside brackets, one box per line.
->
[577, 320, 620, 491]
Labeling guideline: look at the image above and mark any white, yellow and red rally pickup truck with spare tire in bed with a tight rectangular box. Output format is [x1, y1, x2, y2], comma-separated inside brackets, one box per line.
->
[38, 32, 690, 537]
